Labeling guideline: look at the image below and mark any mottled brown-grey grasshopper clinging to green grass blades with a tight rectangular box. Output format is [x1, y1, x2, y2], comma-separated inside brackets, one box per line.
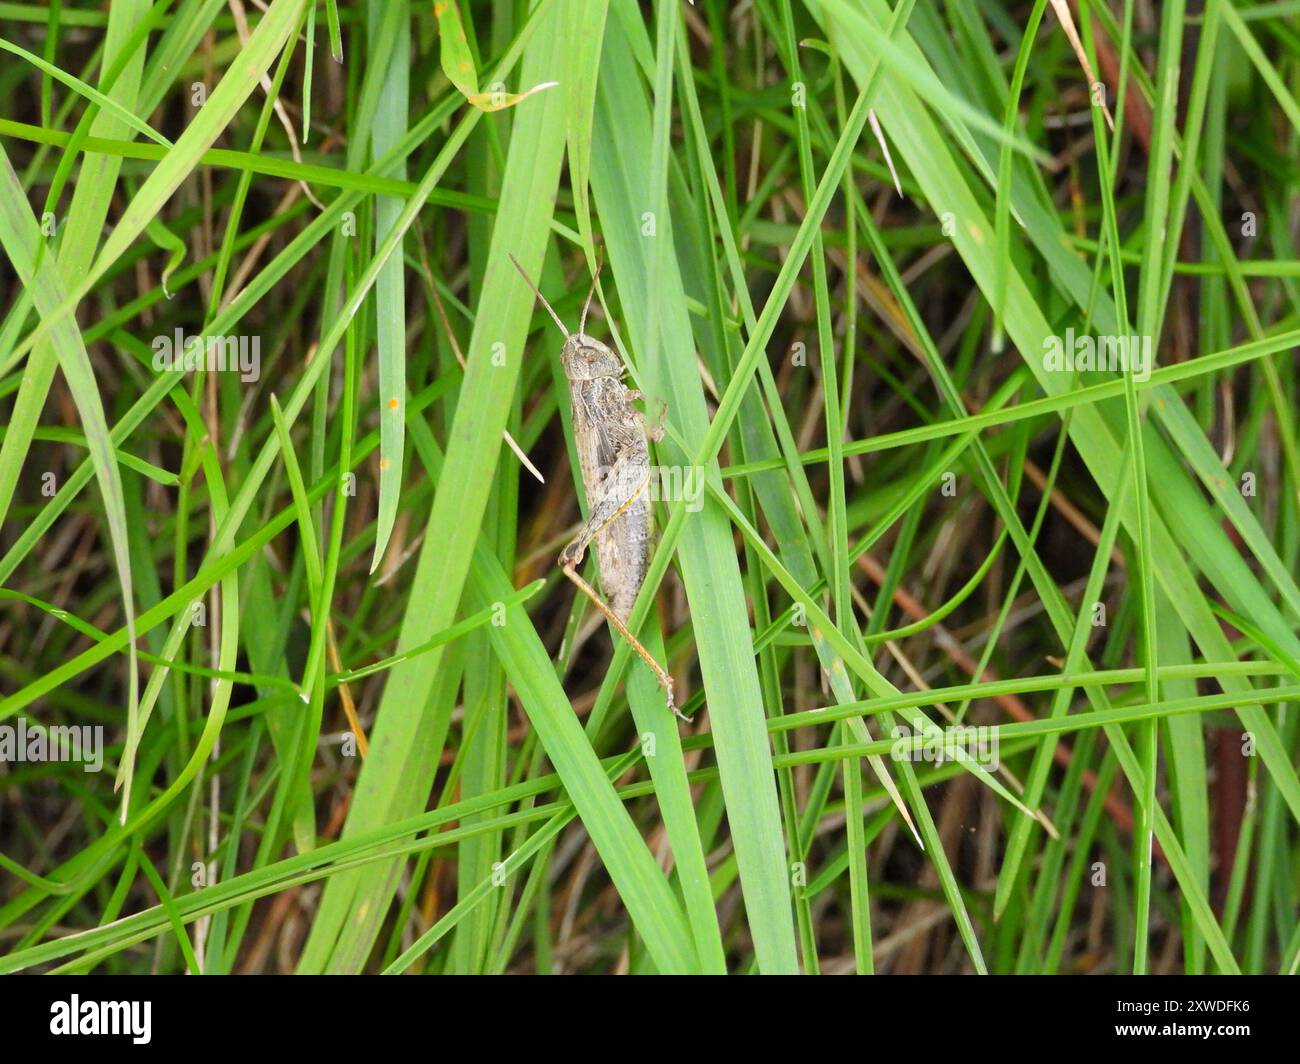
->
[510, 255, 686, 719]
